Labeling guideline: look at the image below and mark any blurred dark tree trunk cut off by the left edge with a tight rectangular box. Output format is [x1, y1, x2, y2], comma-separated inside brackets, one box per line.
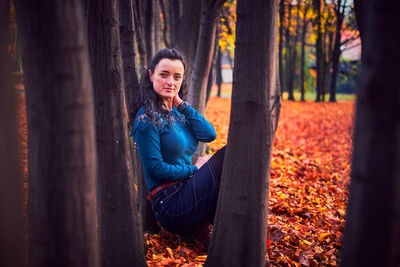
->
[0, 0, 26, 266]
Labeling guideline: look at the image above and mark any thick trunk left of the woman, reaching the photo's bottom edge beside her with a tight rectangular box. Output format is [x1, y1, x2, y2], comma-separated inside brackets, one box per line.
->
[88, 0, 146, 266]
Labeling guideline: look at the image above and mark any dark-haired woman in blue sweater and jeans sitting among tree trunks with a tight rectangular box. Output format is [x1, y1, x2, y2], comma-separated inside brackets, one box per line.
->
[131, 49, 225, 247]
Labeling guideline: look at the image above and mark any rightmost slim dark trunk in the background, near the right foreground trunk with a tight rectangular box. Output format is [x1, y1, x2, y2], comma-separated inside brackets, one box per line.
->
[329, 0, 344, 102]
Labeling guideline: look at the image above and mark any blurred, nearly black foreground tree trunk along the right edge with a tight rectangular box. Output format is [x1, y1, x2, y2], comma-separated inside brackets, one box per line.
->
[341, 0, 400, 267]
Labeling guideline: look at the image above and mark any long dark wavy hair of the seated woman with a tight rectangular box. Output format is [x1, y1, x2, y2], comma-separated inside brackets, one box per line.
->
[131, 48, 188, 126]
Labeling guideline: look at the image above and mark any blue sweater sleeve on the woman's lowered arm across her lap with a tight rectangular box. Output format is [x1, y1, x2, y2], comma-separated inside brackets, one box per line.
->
[133, 119, 198, 182]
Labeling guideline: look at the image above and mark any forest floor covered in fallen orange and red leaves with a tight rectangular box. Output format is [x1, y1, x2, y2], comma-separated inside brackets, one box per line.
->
[18, 91, 354, 266]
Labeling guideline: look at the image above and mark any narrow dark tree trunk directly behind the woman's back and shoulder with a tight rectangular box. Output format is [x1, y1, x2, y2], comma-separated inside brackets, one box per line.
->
[118, 0, 160, 236]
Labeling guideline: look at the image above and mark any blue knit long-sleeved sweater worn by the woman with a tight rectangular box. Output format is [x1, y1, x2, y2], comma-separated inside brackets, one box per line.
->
[131, 106, 216, 192]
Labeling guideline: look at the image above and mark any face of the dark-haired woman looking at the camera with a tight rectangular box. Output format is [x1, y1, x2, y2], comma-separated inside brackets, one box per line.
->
[149, 58, 185, 100]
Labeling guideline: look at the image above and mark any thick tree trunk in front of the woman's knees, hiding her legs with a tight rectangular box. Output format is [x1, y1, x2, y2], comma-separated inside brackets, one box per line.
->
[205, 0, 280, 266]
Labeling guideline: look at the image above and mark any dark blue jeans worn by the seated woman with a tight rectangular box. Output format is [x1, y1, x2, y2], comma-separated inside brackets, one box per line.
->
[151, 146, 225, 234]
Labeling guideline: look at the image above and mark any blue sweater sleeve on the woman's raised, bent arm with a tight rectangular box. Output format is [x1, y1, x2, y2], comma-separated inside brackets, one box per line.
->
[181, 105, 217, 142]
